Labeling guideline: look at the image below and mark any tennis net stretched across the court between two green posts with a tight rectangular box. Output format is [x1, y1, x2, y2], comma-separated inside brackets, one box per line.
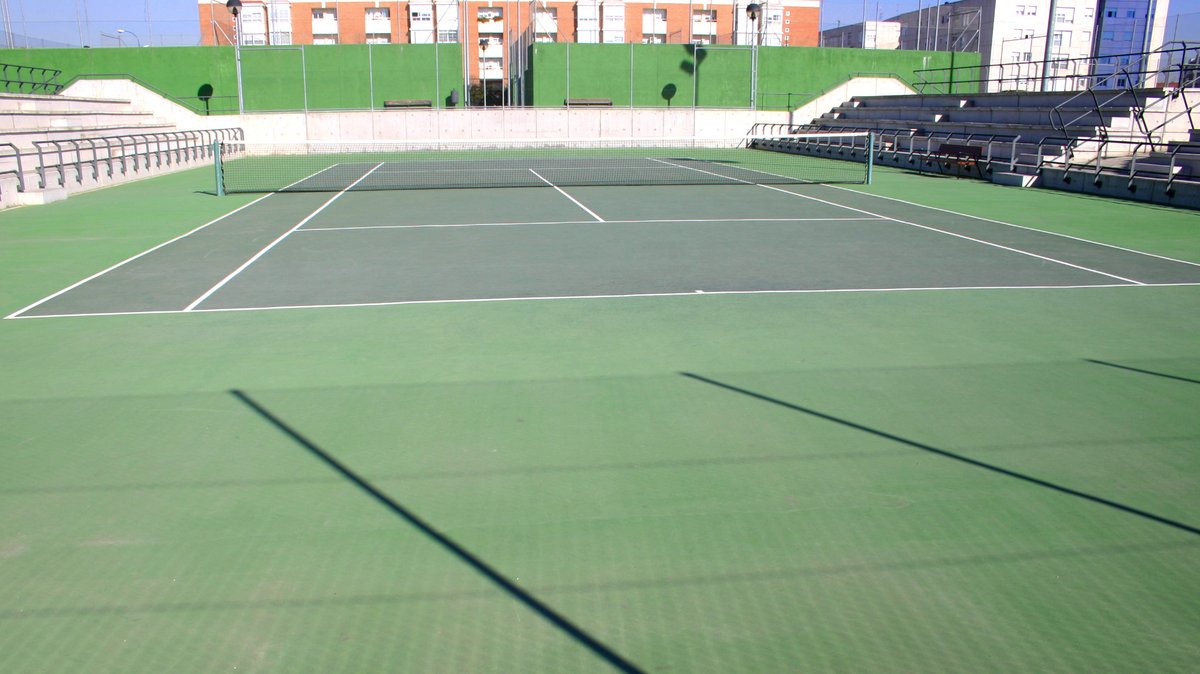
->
[216, 133, 871, 194]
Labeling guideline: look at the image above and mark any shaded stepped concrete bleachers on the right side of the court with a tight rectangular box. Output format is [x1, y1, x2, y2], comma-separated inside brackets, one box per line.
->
[797, 89, 1200, 207]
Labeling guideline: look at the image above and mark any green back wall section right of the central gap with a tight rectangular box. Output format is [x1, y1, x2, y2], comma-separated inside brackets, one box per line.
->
[530, 43, 979, 109]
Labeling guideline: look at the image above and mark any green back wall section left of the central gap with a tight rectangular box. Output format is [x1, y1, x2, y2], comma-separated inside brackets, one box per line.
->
[0, 44, 463, 113]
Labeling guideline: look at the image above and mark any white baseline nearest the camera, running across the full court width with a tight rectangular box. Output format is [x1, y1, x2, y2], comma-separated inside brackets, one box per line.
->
[17, 283, 1200, 320]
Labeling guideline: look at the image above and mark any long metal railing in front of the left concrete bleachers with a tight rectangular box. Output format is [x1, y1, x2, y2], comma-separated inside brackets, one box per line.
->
[34, 128, 245, 191]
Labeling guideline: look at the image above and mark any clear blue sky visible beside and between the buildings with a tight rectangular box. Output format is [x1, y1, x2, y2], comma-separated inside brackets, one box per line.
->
[9, 0, 1200, 47]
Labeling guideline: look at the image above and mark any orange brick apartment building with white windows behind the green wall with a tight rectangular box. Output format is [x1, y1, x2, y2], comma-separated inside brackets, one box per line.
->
[199, 0, 821, 94]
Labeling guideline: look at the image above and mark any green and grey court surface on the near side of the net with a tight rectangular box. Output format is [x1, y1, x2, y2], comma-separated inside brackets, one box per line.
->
[0, 164, 1200, 673]
